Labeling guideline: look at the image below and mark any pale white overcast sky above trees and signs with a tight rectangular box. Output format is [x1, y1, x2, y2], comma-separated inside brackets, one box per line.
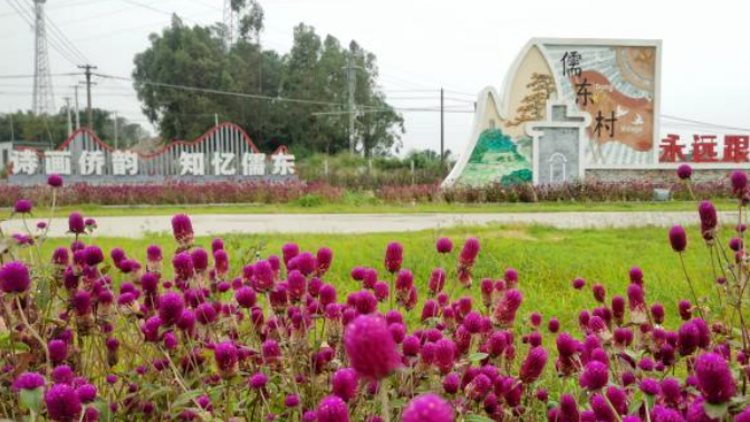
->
[0, 0, 750, 155]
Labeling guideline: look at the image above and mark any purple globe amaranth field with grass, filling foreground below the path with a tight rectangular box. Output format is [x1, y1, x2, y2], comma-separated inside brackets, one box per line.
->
[0, 172, 750, 422]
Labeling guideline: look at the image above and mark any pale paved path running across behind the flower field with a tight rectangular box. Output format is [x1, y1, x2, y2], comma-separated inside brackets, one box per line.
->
[2, 211, 736, 238]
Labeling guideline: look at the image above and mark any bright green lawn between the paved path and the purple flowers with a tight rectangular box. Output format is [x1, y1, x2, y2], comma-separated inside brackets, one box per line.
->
[38, 226, 729, 330]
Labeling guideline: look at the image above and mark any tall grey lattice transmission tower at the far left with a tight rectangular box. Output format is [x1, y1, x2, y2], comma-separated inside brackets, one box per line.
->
[31, 0, 55, 114]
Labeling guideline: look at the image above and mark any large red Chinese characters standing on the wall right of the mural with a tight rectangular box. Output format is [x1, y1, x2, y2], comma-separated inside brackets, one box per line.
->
[659, 134, 750, 163]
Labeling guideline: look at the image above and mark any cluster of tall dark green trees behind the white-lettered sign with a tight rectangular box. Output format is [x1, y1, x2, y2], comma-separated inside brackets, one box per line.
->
[133, 0, 404, 157]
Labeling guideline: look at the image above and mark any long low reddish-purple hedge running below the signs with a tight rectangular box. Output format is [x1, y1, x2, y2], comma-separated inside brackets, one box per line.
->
[0, 176, 732, 207]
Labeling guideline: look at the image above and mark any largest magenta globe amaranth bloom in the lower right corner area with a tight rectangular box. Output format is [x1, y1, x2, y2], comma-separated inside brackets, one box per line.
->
[695, 353, 737, 404]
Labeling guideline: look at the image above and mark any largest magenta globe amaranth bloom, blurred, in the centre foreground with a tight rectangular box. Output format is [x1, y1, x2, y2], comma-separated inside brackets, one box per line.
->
[344, 315, 401, 380]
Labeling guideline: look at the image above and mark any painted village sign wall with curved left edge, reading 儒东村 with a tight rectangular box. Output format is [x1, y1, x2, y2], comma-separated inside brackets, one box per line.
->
[444, 39, 661, 186]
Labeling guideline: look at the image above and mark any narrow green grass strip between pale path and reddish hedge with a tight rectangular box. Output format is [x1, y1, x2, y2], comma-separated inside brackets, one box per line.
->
[0, 200, 736, 218]
